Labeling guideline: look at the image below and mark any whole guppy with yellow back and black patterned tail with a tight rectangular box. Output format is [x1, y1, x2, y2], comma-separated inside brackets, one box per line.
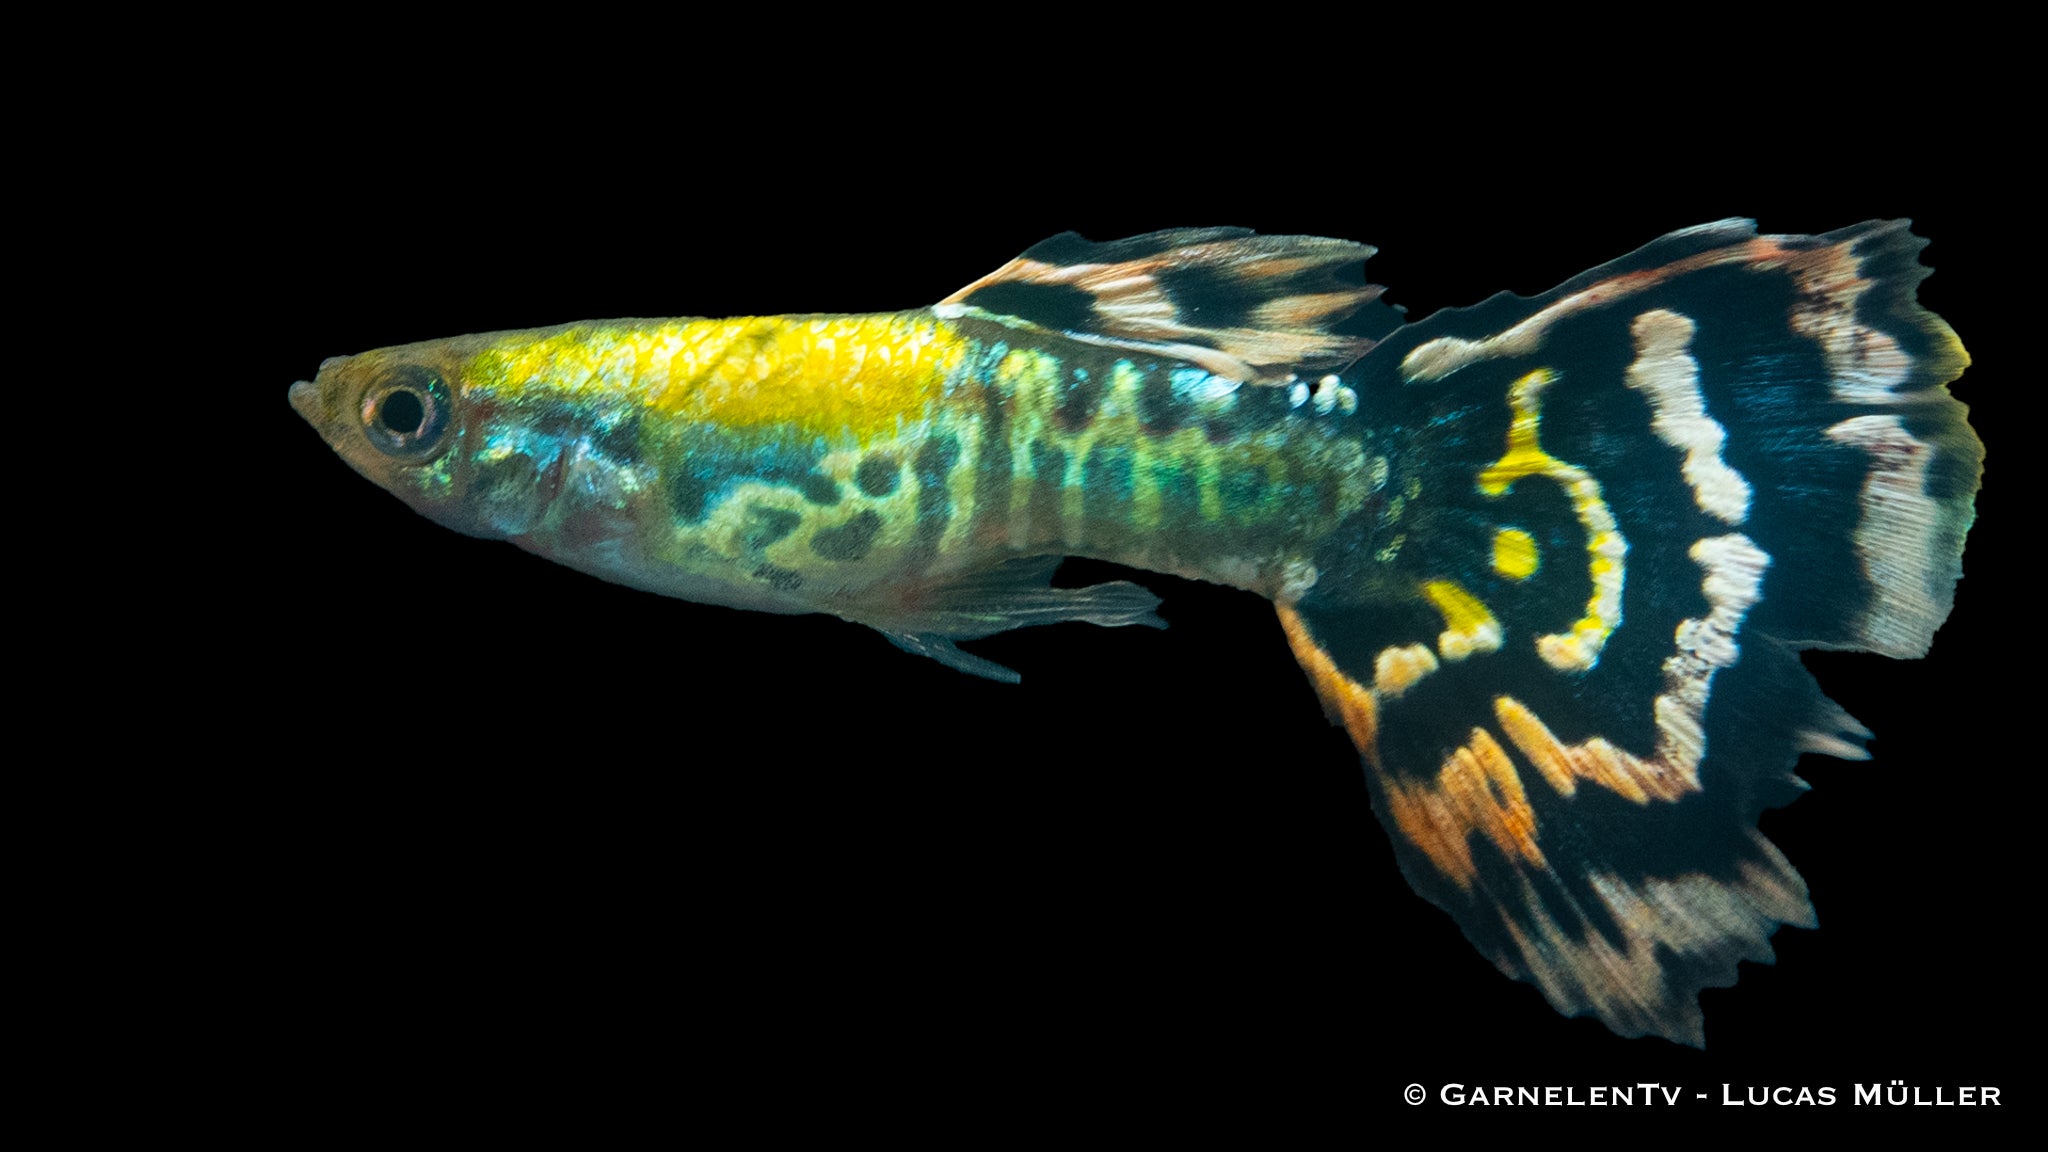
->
[291, 221, 1982, 1043]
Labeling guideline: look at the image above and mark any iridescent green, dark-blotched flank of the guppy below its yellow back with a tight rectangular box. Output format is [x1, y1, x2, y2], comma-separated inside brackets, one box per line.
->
[446, 307, 1364, 610]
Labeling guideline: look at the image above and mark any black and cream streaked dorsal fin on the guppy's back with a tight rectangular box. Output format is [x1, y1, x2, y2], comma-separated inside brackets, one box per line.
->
[936, 228, 1399, 383]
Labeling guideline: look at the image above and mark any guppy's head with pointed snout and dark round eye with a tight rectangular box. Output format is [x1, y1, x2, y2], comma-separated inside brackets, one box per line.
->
[291, 340, 553, 539]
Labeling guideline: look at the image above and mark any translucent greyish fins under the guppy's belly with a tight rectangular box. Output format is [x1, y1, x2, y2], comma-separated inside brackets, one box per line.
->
[856, 556, 1165, 685]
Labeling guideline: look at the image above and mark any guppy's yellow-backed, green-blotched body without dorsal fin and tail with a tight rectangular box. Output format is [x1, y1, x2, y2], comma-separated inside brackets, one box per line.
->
[295, 230, 1386, 678]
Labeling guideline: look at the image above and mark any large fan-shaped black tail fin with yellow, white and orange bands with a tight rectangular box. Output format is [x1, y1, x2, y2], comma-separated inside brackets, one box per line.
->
[1280, 221, 1982, 1043]
